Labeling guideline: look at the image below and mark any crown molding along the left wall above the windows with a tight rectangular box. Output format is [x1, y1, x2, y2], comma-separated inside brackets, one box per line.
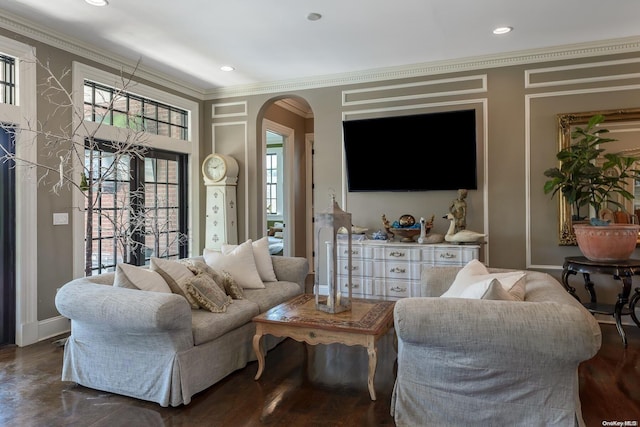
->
[0, 10, 205, 100]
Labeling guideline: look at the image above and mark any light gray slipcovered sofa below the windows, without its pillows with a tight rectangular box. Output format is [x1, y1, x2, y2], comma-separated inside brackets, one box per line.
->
[56, 256, 309, 406]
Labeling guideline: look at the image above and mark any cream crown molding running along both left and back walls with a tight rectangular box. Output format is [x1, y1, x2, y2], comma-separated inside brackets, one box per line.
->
[0, 10, 640, 100]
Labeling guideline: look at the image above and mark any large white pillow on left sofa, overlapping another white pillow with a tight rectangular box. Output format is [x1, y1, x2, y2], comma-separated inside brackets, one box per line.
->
[203, 240, 265, 289]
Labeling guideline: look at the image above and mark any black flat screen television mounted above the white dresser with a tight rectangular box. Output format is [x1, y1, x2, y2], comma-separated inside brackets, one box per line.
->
[342, 110, 478, 192]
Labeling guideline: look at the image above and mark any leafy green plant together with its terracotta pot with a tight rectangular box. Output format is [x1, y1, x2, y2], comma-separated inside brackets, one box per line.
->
[544, 114, 640, 261]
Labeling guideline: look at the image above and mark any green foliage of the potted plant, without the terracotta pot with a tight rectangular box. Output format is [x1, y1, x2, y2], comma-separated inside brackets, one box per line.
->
[544, 114, 640, 224]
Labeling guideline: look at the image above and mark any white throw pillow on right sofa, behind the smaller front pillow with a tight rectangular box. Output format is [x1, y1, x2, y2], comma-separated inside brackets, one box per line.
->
[441, 260, 527, 301]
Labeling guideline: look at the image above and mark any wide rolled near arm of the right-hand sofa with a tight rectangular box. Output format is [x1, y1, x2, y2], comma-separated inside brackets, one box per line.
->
[394, 298, 601, 365]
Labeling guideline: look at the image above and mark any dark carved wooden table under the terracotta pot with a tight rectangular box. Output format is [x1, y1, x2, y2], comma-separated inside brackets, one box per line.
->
[562, 256, 640, 347]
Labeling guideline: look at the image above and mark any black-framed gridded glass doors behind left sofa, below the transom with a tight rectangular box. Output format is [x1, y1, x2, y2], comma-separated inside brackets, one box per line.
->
[85, 143, 187, 274]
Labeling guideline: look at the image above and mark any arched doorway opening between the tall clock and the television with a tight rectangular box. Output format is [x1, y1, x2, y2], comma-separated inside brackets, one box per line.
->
[257, 97, 314, 265]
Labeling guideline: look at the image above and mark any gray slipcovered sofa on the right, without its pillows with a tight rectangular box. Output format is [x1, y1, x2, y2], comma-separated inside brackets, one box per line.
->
[391, 267, 601, 427]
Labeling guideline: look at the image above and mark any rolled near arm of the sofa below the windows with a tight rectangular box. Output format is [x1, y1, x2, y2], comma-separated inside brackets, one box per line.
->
[55, 279, 191, 333]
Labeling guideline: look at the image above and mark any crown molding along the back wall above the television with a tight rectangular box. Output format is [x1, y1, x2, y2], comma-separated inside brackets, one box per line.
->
[205, 36, 640, 99]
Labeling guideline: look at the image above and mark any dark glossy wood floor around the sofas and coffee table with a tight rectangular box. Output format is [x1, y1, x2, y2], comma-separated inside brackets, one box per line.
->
[0, 324, 640, 427]
